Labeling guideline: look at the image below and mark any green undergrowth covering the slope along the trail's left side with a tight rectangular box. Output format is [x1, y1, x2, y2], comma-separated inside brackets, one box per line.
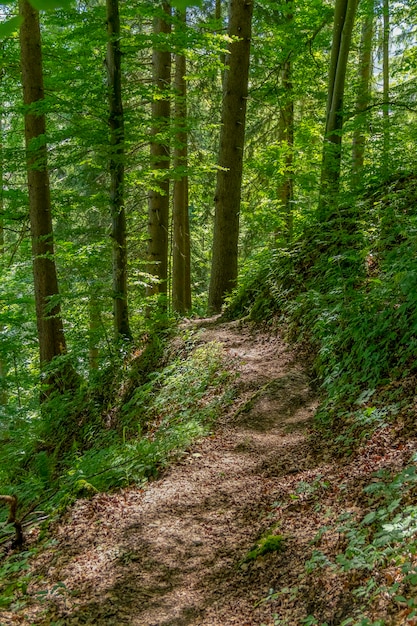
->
[0, 324, 233, 608]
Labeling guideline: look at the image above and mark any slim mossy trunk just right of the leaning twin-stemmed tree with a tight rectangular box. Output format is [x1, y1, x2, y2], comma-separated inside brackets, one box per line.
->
[352, 1, 374, 184]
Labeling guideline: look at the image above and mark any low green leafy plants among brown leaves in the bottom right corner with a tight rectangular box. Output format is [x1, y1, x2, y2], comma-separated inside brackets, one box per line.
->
[305, 465, 417, 626]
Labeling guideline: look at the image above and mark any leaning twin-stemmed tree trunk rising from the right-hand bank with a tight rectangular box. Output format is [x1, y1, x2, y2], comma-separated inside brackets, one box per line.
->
[319, 0, 358, 220]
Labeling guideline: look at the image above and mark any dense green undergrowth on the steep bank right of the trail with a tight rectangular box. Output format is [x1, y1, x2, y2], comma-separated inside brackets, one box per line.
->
[225, 176, 417, 453]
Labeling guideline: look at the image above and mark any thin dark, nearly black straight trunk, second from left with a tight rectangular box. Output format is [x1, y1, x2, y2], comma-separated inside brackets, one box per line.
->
[106, 0, 132, 339]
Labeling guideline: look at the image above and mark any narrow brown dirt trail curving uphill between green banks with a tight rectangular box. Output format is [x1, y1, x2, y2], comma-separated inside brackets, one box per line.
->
[0, 323, 316, 626]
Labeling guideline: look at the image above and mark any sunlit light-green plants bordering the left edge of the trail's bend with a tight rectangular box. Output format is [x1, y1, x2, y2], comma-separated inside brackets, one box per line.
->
[69, 344, 231, 490]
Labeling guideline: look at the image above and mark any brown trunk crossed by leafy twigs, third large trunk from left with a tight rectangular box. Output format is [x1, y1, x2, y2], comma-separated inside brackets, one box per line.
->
[147, 2, 171, 295]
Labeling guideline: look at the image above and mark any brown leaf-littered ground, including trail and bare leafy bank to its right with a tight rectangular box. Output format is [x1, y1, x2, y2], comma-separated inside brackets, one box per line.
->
[0, 320, 417, 626]
